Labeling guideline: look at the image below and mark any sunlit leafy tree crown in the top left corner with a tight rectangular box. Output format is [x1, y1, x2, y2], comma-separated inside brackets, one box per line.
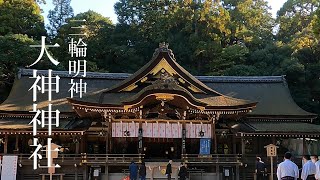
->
[0, 0, 46, 39]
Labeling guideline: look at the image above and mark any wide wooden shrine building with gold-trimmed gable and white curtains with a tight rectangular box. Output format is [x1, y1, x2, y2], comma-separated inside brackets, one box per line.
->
[0, 44, 320, 180]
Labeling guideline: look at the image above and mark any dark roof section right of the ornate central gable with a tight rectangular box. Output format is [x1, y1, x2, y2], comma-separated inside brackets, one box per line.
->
[199, 76, 317, 118]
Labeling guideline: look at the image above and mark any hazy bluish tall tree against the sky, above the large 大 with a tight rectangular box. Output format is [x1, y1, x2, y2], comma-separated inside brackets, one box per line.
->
[47, 0, 73, 38]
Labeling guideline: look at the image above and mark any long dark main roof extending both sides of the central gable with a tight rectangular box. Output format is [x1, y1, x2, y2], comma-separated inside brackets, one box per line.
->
[0, 69, 316, 120]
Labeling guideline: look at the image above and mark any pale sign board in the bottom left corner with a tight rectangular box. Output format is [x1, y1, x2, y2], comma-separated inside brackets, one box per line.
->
[1, 156, 18, 180]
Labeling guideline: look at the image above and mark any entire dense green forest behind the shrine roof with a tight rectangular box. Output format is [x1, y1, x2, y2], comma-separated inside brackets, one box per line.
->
[0, 0, 320, 121]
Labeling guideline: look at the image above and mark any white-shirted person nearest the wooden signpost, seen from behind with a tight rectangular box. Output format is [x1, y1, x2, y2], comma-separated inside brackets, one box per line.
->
[277, 152, 299, 180]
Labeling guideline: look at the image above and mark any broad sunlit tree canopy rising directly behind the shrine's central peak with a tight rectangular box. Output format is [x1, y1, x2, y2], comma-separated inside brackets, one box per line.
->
[115, 0, 274, 74]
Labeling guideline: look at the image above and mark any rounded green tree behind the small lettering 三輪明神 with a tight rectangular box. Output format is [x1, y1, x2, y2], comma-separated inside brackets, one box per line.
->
[52, 10, 114, 71]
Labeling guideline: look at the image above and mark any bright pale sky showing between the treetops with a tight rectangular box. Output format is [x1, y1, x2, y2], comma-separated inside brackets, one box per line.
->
[41, 0, 286, 24]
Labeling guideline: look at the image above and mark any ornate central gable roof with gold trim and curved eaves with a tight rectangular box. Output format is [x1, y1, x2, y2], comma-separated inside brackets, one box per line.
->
[68, 45, 256, 114]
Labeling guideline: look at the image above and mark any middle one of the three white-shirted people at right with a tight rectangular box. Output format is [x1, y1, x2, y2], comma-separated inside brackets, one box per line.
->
[301, 155, 316, 180]
